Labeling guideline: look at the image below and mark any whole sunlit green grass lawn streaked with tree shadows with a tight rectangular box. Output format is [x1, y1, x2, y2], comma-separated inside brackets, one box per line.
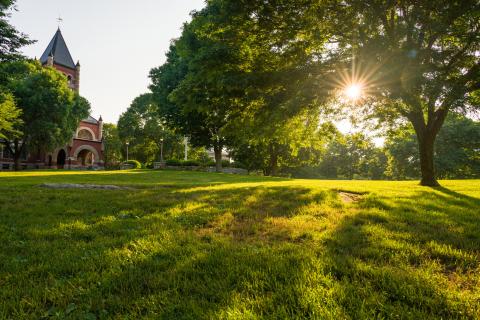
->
[0, 171, 480, 319]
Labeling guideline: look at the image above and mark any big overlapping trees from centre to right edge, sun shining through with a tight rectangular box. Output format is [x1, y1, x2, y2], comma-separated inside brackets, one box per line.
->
[143, 0, 480, 186]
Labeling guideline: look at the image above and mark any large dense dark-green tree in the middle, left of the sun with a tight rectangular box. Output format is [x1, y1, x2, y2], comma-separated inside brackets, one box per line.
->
[151, 0, 328, 170]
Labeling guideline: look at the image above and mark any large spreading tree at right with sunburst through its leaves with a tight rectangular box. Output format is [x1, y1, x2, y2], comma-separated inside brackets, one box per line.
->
[318, 0, 480, 186]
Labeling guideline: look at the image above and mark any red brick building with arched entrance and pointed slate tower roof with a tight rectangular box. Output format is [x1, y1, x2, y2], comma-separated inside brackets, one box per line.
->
[0, 28, 104, 170]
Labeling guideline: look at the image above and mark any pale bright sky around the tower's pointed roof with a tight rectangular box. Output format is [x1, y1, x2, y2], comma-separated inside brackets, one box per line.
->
[10, 0, 204, 123]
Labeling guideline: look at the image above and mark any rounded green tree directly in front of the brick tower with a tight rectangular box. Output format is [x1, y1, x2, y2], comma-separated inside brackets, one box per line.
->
[0, 61, 90, 170]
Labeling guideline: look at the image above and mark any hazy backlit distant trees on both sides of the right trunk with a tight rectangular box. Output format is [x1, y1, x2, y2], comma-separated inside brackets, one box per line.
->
[283, 114, 480, 180]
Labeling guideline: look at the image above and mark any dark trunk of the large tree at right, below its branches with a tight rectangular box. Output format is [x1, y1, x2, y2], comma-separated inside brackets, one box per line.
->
[418, 132, 439, 187]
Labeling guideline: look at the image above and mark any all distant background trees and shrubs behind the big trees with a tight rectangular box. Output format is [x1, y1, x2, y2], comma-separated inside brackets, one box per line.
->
[104, 94, 480, 180]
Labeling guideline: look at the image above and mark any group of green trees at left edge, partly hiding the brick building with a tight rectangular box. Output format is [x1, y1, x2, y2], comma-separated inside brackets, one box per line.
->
[0, 0, 90, 170]
